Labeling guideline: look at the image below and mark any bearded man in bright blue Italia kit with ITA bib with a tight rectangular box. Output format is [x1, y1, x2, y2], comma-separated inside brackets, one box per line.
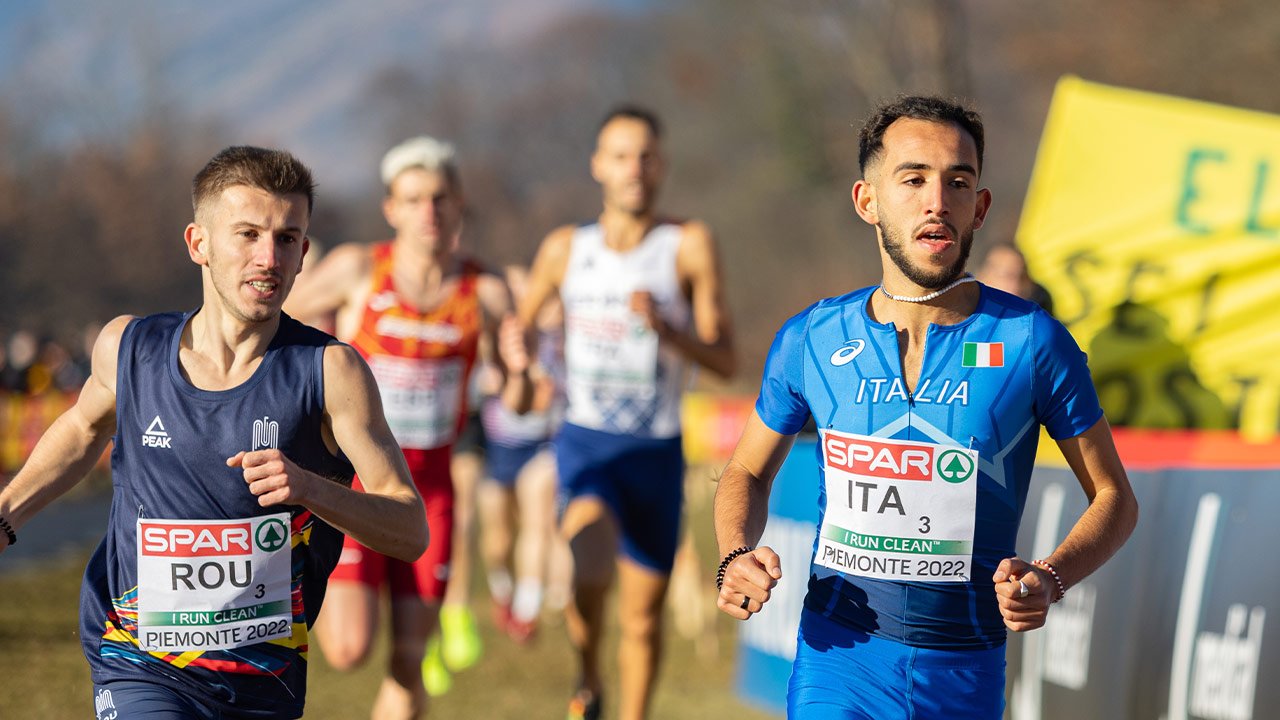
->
[716, 97, 1138, 720]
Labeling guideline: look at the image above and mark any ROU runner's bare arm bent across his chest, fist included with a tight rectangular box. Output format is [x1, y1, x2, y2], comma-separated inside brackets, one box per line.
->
[227, 343, 430, 561]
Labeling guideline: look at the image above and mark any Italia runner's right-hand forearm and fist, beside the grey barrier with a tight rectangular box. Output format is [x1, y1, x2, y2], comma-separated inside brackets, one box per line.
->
[992, 418, 1138, 632]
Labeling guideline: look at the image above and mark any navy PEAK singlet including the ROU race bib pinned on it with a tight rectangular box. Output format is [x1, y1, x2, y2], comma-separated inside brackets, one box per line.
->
[81, 313, 352, 717]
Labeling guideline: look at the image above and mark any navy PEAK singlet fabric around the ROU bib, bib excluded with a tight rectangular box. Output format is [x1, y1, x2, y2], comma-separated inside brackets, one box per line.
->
[81, 313, 353, 717]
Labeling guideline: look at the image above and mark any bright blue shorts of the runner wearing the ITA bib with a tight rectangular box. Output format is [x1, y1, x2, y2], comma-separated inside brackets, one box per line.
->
[787, 609, 1005, 720]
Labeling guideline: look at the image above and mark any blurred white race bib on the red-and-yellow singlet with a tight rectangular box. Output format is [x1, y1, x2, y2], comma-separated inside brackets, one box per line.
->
[369, 355, 466, 450]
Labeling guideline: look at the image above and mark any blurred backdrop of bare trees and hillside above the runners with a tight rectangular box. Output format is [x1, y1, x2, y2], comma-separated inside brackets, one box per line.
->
[0, 0, 1280, 379]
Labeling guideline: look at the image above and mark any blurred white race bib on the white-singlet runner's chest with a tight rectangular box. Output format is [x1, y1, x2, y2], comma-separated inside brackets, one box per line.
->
[564, 301, 658, 397]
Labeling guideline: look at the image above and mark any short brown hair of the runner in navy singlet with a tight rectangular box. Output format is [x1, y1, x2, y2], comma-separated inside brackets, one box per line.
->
[191, 145, 316, 218]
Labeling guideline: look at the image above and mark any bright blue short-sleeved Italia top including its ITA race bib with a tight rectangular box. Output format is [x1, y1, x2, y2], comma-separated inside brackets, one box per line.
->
[755, 286, 1102, 650]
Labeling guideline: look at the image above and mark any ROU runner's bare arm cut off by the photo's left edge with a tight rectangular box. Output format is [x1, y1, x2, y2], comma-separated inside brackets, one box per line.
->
[0, 315, 132, 552]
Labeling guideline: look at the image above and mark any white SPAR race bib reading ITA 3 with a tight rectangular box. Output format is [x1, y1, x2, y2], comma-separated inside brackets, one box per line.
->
[814, 430, 978, 583]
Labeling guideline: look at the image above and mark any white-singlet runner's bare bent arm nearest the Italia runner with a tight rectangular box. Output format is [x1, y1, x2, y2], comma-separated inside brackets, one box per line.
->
[654, 220, 737, 378]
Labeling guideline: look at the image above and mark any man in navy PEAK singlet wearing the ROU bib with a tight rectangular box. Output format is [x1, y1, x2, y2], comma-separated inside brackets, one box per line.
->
[0, 147, 428, 720]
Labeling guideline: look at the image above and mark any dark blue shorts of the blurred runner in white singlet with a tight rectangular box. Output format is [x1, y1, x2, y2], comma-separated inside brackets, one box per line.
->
[556, 423, 685, 573]
